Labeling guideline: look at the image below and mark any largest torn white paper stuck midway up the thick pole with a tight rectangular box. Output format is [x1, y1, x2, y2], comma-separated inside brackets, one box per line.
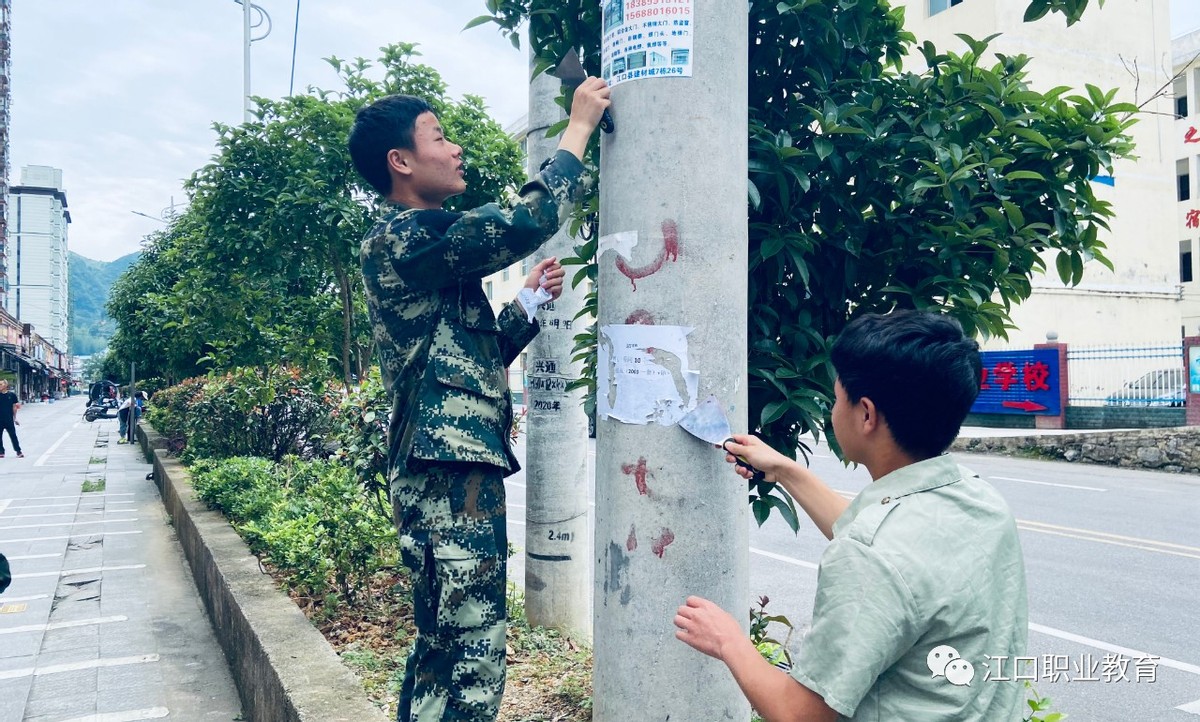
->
[596, 324, 700, 426]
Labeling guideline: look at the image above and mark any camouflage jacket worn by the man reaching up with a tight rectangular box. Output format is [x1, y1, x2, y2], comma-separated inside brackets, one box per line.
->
[360, 151, 583, 476]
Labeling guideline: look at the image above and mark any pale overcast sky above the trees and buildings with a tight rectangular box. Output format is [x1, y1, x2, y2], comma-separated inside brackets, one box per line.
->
[10, 0, 1200, 260]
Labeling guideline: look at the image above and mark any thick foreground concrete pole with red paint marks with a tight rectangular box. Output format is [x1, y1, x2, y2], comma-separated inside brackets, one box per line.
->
[593, 0, 750, 722]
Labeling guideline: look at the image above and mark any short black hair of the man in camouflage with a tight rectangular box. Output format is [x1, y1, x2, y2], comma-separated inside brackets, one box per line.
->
[349, 94, 433, 195]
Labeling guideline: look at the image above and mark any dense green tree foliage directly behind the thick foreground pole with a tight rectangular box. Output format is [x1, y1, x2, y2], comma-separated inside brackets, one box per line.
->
[473, 0, 1136, 460]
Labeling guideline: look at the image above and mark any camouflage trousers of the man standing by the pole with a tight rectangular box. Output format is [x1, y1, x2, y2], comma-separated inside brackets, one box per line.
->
[391, 463, 508, 722]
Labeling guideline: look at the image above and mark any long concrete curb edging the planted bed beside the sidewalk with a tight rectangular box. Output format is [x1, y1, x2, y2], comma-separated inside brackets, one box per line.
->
[138, 422, 386, 722]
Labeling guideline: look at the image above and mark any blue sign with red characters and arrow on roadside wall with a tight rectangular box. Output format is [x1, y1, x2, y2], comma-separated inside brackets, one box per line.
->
[971, 349, 1062, 416]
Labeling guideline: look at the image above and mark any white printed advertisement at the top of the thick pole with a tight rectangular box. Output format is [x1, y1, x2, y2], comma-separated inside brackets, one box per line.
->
[600, 0, 694, 85]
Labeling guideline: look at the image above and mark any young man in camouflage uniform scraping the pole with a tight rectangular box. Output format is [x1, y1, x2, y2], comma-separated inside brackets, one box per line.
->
[349, 78, 608, 722]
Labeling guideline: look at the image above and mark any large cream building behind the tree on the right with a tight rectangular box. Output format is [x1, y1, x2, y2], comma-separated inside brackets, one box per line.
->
[895, 0, 1180, 345]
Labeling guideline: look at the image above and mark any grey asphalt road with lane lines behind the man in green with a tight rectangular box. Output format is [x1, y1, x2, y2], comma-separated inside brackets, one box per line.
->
[508, 429, 1200, 722]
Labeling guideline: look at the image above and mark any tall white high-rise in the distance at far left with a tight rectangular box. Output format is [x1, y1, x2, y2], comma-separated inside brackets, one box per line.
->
[6, 166, 71, 351]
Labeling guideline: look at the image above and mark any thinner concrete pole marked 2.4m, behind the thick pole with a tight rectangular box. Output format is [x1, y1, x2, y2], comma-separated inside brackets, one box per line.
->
[526, 47, 592, 640]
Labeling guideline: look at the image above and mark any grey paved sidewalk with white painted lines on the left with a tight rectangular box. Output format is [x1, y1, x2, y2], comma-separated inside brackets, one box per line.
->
[0, 397, 241, 722]
